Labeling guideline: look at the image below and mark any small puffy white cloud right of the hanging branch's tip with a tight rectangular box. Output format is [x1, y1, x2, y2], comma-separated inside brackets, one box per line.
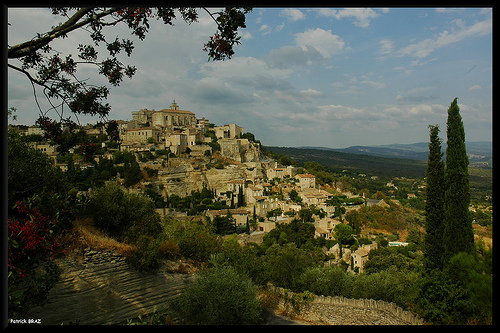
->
[295, 28, 348, 58]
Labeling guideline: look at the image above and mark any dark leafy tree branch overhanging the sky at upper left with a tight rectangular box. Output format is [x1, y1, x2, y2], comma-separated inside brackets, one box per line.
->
[7, 7, 251, 127]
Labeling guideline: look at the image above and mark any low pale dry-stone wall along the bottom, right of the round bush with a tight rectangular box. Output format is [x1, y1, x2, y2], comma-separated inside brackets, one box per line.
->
[268, 286, 424, 325]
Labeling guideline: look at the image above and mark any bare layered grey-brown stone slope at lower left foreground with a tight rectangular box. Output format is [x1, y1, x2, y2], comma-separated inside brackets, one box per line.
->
[25, 250, 194, 325]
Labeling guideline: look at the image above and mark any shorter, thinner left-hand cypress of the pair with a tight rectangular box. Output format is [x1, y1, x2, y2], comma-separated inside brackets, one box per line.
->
[424, 125, 445, 272]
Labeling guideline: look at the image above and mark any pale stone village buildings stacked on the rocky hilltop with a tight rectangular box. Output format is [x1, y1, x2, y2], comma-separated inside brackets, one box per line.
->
[11, 101, 426, 272]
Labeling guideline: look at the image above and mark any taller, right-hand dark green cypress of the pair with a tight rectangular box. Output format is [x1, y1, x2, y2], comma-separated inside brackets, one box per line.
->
[444, 98, 474, 265]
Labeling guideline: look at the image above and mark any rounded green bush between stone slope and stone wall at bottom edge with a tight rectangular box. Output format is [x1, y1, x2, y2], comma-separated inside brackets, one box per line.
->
[171, 266, 263, 325]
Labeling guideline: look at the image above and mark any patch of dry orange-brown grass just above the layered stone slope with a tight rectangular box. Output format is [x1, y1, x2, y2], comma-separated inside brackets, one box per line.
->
[70, 218, 135, 255]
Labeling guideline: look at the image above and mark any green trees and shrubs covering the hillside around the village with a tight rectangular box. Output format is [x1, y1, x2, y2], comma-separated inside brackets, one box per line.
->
[8, 127, 492, 324]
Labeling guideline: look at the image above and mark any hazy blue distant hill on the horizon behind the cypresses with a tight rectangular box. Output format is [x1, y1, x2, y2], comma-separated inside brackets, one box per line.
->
[300, 141, 493, 166]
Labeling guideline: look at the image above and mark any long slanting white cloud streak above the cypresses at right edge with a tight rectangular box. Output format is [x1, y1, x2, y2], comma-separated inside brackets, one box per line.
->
[399, 17, 492, 59]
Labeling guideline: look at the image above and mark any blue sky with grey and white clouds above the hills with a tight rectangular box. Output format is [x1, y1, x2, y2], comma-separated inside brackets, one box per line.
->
[7, 8, 493, 148]
